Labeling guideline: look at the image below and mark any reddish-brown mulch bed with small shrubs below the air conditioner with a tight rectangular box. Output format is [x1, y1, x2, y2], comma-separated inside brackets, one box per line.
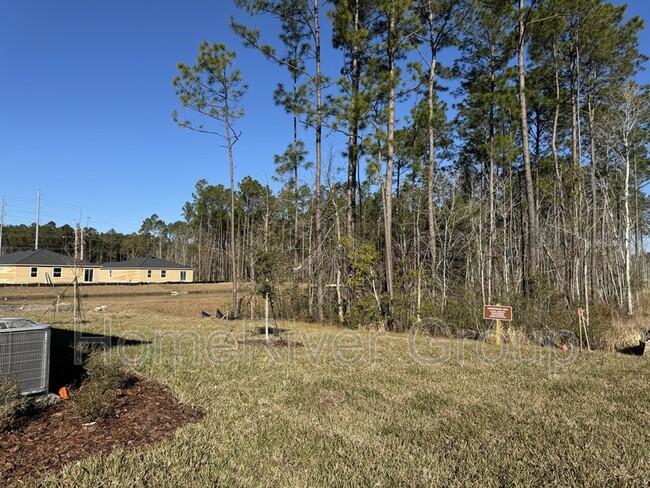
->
[0, 380, 204, 486]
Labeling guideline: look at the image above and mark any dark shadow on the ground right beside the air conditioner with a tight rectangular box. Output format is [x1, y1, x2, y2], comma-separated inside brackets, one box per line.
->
[49, 327, 150, 393]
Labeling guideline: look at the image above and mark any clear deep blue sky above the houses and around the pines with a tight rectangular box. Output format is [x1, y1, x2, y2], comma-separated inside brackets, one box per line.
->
[0, 0, 650, 233]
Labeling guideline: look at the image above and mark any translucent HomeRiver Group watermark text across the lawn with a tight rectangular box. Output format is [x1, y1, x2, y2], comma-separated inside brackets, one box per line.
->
[73, 319, 578, 374]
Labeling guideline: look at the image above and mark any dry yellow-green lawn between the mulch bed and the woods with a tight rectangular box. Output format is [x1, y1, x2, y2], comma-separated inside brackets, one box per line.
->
[0, 287, 650, 487]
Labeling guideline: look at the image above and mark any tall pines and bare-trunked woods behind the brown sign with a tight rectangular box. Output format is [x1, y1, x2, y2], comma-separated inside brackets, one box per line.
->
[3, 0, 650, 336]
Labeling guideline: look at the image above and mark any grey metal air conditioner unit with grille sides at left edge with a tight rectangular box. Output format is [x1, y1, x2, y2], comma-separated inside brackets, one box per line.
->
[0, 319, 50, 395]
